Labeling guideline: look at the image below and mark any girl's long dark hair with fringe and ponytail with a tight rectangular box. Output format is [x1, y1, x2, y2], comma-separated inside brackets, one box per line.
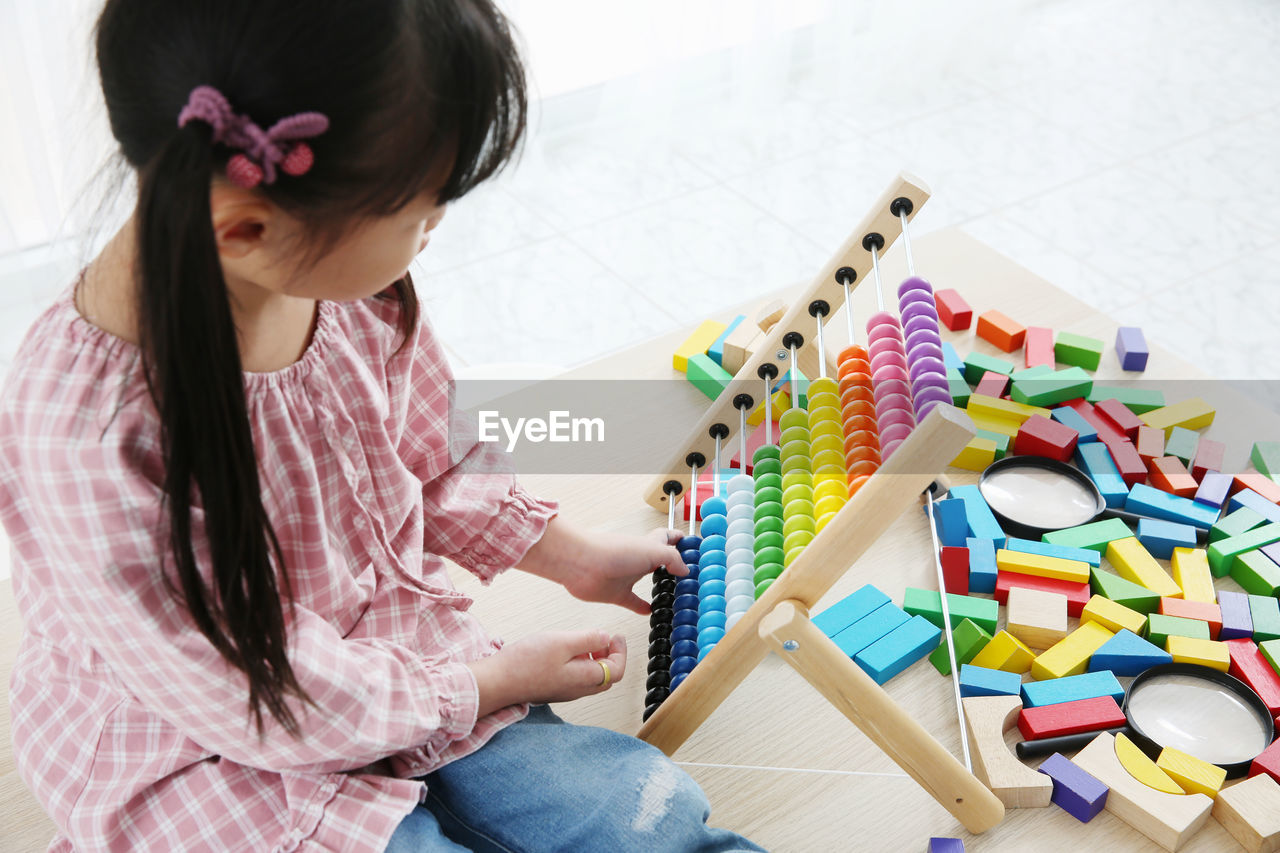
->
[97, 0, 526, 736]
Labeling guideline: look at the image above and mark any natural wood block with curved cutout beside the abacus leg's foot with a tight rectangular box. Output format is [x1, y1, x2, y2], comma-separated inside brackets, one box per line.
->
[963, 695, 1053, 808]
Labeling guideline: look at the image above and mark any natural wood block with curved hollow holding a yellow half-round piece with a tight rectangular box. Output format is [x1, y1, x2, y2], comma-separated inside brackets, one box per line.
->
[1075, 734, 1213, 850]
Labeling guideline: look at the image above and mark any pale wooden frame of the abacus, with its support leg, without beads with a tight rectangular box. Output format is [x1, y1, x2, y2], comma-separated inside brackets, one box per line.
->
[637, 174, 1005, 833]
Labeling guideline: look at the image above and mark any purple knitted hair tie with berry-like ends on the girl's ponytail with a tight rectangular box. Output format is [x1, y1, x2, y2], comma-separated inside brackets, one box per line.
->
[178, 86, 329, 190]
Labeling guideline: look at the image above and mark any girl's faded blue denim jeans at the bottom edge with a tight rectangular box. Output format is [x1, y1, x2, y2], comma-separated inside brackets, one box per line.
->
[387, 704, 762, 853]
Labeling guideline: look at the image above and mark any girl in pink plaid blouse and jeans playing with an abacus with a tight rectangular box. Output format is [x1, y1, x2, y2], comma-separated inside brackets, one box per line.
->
[0, 0, 759, 852]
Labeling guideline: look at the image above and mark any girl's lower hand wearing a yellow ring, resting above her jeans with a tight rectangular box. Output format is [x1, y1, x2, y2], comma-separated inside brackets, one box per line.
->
[470, 630, 627, 717]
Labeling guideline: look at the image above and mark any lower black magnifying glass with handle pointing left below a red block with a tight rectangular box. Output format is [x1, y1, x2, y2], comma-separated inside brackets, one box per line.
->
[1015, 663, 1275, 779]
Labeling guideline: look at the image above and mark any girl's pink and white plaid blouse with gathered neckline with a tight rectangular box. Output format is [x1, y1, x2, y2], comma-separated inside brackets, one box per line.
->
[0, 286, 556, 852]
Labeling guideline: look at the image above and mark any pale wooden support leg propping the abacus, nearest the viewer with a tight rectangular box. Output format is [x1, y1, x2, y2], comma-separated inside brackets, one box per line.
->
[759, 599, 1005, 834]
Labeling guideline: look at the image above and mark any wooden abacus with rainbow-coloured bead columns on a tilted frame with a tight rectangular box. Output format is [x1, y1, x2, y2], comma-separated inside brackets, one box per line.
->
[639, 174, 1004, 833]
